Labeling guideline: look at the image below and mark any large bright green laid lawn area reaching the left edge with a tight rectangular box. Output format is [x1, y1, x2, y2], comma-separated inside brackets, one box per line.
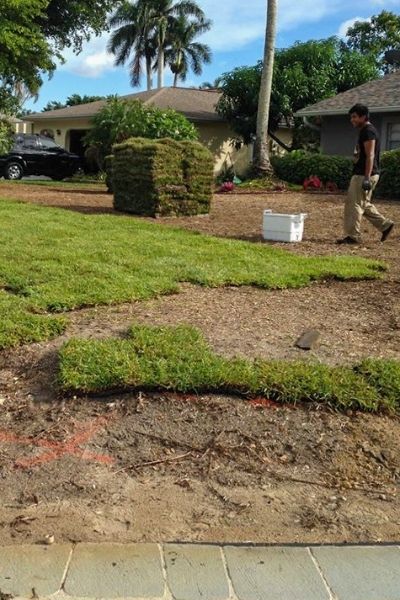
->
[0, 199, 385, 349]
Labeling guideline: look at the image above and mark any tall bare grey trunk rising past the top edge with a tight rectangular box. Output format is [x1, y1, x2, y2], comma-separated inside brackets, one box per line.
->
[253, 0, 278, 177]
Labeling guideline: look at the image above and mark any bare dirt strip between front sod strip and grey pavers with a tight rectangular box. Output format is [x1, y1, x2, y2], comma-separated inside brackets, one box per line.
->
[0, 395, 400, 543]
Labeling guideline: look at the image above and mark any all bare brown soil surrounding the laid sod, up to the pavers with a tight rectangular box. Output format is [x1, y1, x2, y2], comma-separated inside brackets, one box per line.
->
[0, 183, 400, 543]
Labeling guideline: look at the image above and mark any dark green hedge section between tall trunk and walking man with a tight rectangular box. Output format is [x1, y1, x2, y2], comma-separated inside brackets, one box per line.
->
[271, 150, 353, 190]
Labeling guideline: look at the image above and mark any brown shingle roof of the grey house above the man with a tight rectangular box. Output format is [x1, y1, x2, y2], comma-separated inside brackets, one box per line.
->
[296, 71, 400, 117]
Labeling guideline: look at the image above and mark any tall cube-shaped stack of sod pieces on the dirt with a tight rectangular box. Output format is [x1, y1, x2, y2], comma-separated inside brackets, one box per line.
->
[112, 138, 213, 217]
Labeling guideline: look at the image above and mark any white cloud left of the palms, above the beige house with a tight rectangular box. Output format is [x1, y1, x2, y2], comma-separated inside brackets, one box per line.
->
[60, 34, 116, 79]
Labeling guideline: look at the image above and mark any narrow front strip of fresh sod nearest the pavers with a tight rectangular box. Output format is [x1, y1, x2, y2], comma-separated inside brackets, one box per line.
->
[59, 325, 400, 412]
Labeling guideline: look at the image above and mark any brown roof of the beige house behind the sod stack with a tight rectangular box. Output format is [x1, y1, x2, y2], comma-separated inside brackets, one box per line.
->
[26, 87, 223, 121]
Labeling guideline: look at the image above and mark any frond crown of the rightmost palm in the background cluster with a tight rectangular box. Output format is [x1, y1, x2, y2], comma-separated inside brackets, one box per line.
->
[165, 15, 211, 87]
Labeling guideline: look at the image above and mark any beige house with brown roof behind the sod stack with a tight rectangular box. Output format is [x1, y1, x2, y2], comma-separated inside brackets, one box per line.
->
[25, 87, 291, 175]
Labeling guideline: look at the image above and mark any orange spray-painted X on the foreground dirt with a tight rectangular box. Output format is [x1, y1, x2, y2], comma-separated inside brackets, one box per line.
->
[0, 417, 115, 469]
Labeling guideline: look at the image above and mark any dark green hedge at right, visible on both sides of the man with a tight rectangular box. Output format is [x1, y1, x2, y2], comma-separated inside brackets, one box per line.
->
[271, 150, 400, 199]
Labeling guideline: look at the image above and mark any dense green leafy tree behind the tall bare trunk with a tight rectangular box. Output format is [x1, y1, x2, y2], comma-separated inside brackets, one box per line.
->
[217, 37, 379, 144]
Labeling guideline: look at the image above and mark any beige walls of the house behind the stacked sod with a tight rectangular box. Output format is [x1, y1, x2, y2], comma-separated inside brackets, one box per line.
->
[24, 119, 291, 177]
